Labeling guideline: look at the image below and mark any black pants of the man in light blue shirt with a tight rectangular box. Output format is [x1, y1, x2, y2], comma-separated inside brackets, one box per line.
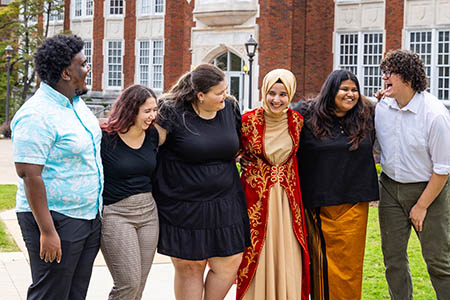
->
[17, 211, 101, 300]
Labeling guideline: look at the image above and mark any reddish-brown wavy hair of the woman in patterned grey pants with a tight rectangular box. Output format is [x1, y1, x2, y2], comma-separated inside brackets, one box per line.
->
[101, 84, 156, 133]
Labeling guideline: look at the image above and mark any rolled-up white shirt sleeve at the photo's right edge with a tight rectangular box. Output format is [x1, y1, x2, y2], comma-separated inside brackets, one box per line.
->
[428, 114, 450, 175]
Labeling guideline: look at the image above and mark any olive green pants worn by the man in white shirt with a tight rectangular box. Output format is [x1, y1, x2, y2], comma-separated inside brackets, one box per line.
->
[379, 174, 450, 300]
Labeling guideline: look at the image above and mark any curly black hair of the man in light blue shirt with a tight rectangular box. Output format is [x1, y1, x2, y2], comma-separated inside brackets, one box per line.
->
[34, 34, 84, 86]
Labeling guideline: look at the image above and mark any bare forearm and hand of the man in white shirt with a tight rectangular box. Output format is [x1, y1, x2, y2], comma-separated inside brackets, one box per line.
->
[409, 172, 448, 231]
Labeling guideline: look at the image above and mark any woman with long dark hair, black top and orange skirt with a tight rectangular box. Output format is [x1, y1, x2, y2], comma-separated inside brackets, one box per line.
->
[296, 70, 379, 300]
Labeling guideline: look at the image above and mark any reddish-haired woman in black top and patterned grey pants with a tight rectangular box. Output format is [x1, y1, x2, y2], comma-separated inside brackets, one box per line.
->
[101, 85, 159, 300]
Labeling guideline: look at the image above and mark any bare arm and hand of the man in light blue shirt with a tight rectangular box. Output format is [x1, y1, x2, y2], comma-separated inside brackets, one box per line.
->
[15, 163, 62, 263]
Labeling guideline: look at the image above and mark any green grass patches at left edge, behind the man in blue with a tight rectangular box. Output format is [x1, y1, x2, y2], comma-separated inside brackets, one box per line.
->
[0, 184, 19, 252]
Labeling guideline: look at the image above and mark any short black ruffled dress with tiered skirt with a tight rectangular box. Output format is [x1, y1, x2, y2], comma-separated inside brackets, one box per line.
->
[153, 100, 250, 260]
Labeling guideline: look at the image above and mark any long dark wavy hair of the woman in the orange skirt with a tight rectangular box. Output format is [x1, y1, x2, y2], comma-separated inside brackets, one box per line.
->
[305, 70, 374, 150]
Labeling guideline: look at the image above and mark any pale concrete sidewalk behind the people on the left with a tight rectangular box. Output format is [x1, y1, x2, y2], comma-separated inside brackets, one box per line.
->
[0, 139, 236, 300]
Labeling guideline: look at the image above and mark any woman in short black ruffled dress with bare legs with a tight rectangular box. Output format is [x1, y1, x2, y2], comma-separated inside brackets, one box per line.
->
[153, 64, 250, 300]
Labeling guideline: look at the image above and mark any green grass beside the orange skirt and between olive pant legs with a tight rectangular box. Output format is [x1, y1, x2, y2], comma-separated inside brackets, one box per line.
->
[362, 207, 435, 300]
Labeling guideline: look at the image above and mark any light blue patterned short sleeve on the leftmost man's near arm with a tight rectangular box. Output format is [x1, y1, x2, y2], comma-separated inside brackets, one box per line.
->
[11, 112, 56, 165]
